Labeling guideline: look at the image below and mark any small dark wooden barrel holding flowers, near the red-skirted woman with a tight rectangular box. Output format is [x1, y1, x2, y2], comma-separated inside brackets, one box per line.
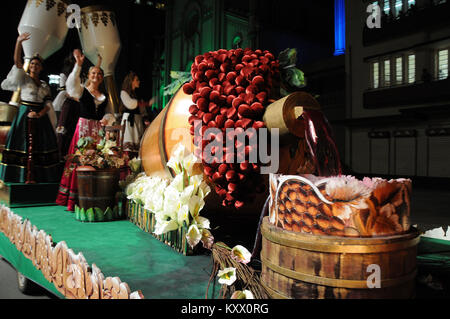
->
[77, 169, 119, 211]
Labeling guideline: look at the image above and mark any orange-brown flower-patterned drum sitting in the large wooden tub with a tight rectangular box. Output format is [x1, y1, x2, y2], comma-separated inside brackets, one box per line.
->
[269, 175, 411, 237]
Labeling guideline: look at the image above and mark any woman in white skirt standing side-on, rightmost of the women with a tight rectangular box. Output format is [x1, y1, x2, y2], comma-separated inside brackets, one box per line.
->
[119, 71, 152, 158]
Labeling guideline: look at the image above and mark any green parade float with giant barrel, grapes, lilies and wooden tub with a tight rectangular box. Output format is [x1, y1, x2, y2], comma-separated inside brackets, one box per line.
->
[0, 0, 418, 299]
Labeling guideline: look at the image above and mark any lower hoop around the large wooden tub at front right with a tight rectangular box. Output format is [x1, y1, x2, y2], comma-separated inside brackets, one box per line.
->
[261, 254, 417, 289]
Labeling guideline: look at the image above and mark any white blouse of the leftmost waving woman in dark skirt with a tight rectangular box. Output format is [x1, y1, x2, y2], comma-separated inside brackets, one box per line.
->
[1, 65, 52, 104]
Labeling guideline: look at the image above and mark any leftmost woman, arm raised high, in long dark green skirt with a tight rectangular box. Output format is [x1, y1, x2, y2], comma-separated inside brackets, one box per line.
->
[0, 33, 61, 183]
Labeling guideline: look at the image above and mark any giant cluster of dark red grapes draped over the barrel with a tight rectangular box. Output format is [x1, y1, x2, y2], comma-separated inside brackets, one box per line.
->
[183, 49, 279, 209]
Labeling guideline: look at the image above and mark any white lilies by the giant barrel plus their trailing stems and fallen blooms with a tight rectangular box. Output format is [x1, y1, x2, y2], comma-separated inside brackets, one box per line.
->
[125, 144, 267, 299]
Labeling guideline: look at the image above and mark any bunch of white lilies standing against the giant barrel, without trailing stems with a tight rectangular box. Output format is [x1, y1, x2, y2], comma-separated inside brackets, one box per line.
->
[125, 144, 214, 248]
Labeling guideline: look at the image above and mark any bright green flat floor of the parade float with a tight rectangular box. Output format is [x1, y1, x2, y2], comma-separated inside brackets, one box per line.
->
[0, 206, 219, 299]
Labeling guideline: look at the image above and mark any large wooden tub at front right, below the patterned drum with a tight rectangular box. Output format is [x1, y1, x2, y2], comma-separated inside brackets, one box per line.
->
[261, 217, 420, 299]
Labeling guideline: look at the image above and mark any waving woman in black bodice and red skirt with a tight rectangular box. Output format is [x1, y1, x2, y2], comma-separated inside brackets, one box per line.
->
[56, 50, 115, 211]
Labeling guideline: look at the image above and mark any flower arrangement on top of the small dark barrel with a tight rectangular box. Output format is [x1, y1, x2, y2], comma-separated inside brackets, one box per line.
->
[67, 131, 128, 170]
